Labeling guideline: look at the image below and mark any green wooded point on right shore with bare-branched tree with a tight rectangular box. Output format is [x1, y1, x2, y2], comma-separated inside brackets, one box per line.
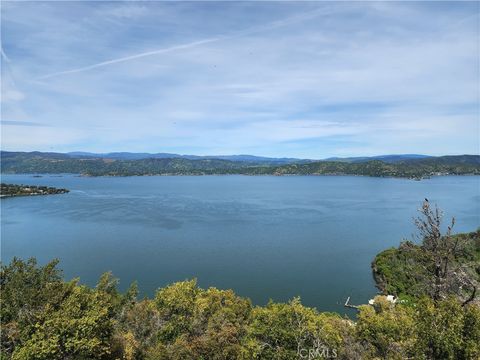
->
[372, 199, 480, 305]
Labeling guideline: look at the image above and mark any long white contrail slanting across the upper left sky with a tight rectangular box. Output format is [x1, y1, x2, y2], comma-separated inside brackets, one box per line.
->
[36, 9, 331, 80]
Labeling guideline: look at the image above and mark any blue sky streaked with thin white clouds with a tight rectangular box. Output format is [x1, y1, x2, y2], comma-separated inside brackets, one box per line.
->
[1, 1, 480, 159]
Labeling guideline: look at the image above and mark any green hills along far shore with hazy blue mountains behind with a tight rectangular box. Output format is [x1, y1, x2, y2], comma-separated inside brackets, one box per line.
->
[0, 151, 480, 178]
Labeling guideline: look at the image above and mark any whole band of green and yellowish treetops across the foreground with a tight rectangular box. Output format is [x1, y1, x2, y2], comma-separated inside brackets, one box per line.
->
[0, 259, 480, 360]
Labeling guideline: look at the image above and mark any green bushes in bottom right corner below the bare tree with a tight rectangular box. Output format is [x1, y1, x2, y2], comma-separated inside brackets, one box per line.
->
[357, 296, 480, 360]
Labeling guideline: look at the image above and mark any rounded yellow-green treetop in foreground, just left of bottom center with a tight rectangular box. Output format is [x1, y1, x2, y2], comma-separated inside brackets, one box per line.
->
[148, 280, 251, 359]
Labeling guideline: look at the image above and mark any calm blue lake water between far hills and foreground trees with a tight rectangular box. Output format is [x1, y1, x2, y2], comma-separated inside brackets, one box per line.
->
[1, 175, 480, 313]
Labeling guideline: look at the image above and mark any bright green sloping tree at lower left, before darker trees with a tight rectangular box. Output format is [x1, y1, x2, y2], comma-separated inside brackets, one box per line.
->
[12, 284, 114, 360]
